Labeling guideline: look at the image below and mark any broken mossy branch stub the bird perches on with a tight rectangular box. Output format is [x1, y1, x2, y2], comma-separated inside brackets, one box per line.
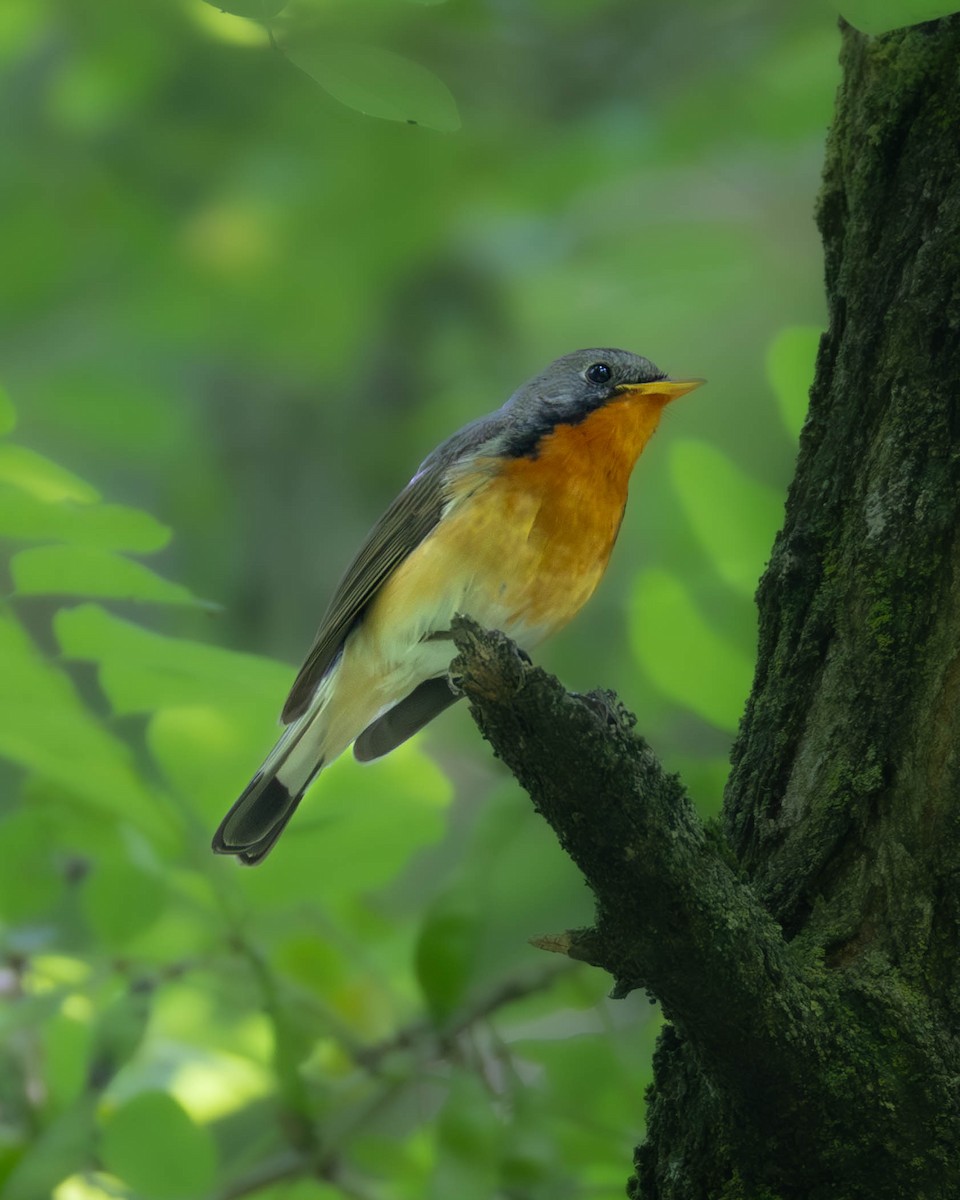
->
[450, 617, 820, 1117]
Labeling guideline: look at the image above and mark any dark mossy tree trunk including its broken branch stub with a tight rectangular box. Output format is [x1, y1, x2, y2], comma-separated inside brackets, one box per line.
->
[455, 17, 960, 1200]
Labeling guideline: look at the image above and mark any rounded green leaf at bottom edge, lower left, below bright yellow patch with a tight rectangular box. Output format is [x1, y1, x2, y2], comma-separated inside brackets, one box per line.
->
[101, 1092, 217, 1200]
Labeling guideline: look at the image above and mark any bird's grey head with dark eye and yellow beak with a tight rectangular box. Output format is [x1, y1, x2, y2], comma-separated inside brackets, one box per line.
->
[500, 348, 702, 457]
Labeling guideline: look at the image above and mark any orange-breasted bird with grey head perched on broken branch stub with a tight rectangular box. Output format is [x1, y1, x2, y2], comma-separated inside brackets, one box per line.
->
[212, 349, 704, 865]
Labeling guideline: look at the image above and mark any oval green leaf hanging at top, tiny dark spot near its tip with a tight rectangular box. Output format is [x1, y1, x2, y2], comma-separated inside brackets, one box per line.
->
[286, 38, 460, 133]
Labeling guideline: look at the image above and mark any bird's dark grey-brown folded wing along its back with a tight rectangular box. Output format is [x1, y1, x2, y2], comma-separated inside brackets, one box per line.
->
[281, 418, 500, 724]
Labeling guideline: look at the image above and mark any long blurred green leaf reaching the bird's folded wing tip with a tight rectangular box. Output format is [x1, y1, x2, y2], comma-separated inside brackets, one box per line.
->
[54, 604, 294, 710]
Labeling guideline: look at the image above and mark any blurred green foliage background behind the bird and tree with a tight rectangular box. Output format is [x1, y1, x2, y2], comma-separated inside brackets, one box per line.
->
[0, 0, 839, 1200]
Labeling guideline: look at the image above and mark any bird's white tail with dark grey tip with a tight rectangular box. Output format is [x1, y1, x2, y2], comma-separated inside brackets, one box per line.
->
[212, 713, 324, 865]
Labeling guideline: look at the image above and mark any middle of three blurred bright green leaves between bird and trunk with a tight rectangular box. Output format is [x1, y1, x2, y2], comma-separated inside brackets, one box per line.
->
[670, 440, 784, 596]
